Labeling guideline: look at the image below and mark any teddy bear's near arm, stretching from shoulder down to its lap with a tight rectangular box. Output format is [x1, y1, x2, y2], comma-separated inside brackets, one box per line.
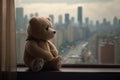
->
[26, 41, 53, 61]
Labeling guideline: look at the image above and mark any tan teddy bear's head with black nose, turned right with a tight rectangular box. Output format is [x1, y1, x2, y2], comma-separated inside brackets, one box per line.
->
[27, 17, 56, 40]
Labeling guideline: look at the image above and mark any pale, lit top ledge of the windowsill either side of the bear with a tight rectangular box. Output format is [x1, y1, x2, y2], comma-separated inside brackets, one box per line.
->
[17, 67, 120, 72]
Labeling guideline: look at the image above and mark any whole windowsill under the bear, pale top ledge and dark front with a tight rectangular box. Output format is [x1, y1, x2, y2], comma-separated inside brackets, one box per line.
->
[17, 67, 120, 80]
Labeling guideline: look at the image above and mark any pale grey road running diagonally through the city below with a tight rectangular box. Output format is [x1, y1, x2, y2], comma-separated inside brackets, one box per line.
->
[62, 41, 88, 64]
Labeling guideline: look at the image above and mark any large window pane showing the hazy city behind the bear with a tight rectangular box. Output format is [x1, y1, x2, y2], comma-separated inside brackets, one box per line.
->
[16, 0, 120, 65]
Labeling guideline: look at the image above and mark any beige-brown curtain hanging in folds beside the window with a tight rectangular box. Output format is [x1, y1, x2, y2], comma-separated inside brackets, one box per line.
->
[0, 0, 16, 80]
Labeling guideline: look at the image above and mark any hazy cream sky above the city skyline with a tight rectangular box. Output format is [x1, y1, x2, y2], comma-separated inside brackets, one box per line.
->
[16, 0, 120, 21]
